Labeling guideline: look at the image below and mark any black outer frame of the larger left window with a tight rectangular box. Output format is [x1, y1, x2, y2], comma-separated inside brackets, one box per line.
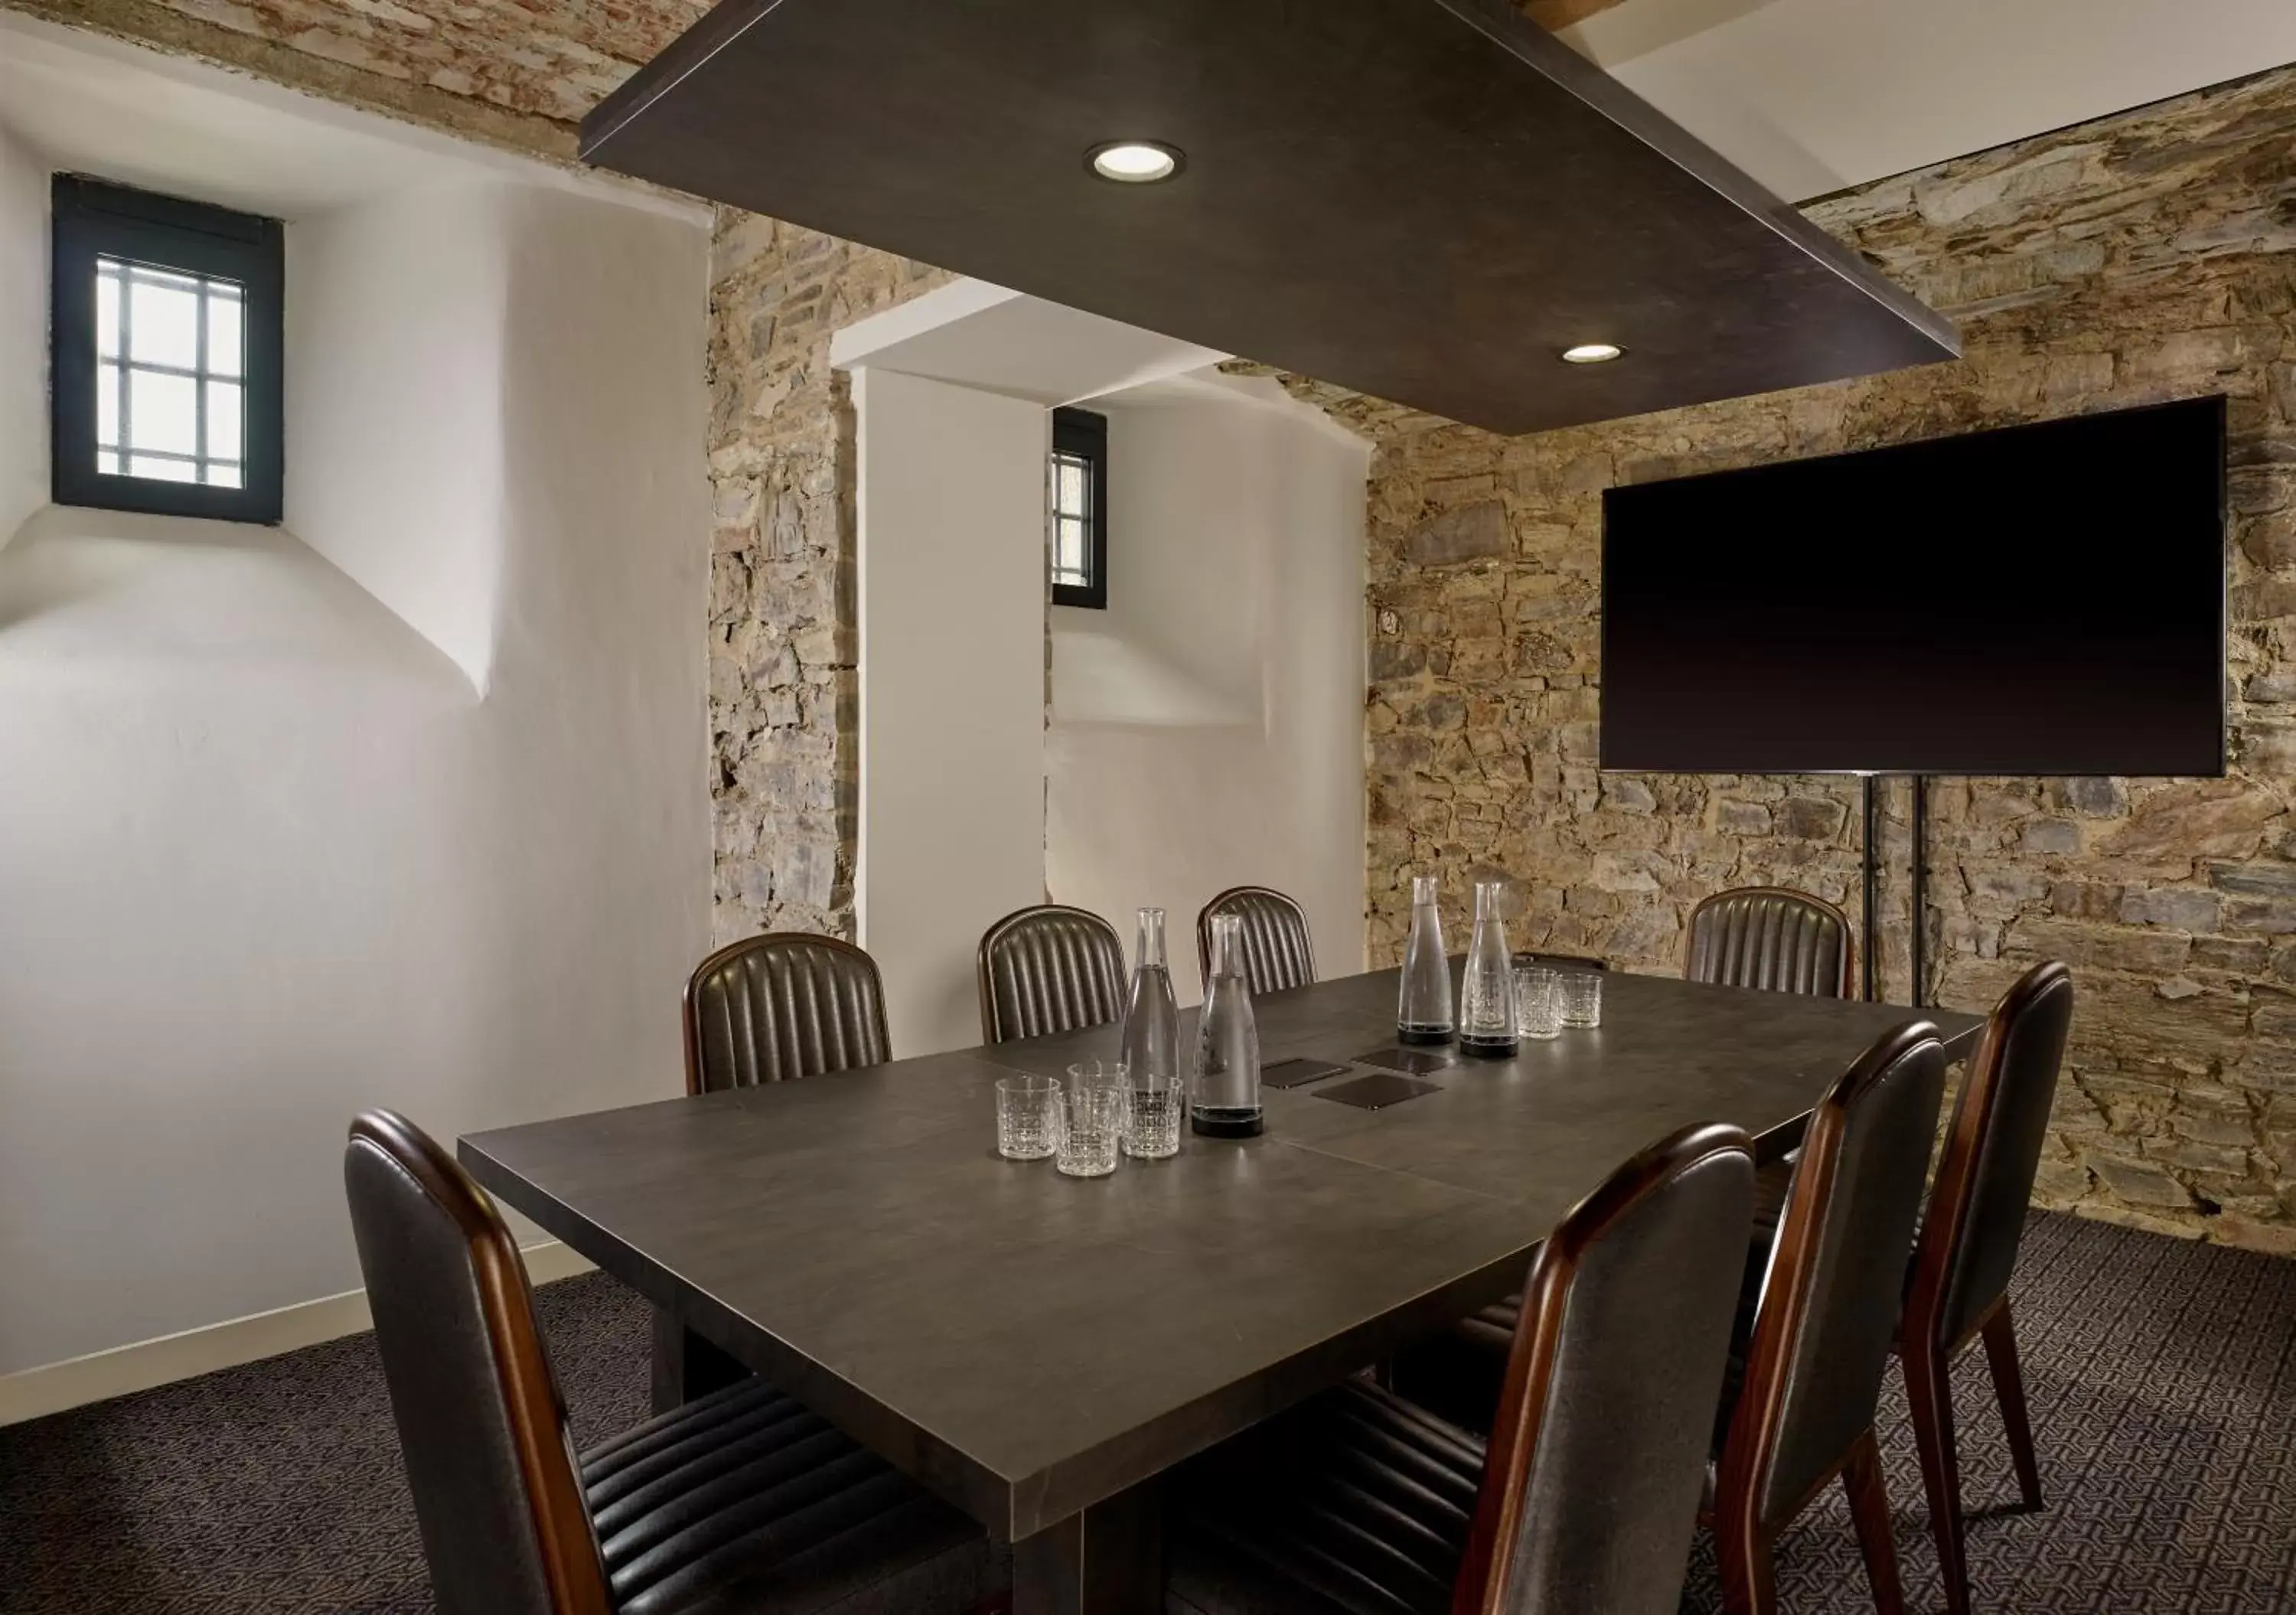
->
[48, 175, 287, 526]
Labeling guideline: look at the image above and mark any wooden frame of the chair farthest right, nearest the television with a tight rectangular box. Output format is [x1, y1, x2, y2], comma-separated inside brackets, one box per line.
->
[1896, 961, 2073, 1615]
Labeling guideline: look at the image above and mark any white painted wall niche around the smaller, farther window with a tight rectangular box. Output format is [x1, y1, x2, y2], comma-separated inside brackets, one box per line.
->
[831, 280, 1368, 1029]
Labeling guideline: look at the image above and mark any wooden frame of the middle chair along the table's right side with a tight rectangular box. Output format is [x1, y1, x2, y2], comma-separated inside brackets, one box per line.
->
[1704, 1020, 1938, 1615]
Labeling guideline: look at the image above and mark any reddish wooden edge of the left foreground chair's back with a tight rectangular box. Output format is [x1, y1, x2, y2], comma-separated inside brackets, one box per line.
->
[351, 1110, 613, 1615]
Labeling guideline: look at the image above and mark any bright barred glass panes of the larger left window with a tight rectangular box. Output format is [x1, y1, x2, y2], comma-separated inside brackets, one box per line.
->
[96, 257, 246, 487]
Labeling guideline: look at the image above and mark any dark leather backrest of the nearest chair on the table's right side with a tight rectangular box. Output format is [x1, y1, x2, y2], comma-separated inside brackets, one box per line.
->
[1453, 1126, 1754, 1615]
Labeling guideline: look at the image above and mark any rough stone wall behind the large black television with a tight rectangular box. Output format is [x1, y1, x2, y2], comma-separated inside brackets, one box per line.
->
[1341, 69, 2296, 1254]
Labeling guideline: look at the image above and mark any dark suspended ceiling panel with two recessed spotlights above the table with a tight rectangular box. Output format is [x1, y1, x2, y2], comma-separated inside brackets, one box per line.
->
[581, 0, 1961, 434]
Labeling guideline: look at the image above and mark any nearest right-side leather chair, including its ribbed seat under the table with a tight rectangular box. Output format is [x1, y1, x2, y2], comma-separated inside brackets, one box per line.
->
[1166, 1126, 1754, 1615]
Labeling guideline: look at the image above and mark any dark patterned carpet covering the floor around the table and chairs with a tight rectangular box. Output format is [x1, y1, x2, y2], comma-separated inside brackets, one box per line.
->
[0, 1218, 2296, 1615]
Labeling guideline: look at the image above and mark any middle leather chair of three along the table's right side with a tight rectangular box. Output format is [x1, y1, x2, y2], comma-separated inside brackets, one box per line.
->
[1706, 1020, 1945, 1615]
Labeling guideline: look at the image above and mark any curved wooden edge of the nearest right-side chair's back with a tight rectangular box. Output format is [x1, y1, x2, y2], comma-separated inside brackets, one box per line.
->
[1451, 1126, 1754, 1615]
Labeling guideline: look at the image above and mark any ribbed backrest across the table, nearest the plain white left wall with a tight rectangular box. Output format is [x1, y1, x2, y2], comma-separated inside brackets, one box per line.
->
[687, 931, 893, 1094]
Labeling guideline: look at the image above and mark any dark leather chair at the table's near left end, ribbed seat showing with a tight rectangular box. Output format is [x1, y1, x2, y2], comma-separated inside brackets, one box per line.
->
[342, 1110, 1001, 1615]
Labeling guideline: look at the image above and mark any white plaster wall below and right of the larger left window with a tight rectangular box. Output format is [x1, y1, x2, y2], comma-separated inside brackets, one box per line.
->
[0, 158, 709, 1374]
